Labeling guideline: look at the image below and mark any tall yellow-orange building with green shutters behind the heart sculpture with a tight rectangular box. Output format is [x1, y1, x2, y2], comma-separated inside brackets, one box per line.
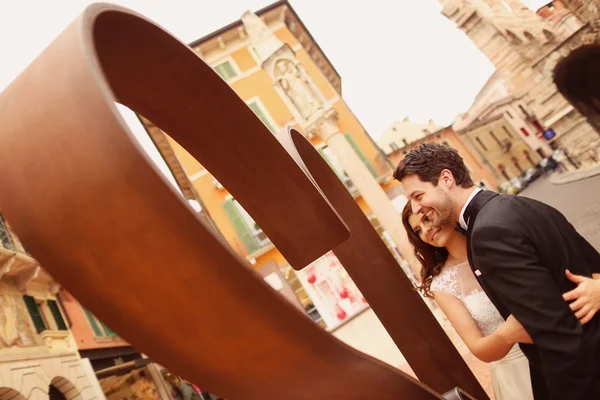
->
[142, 1, 408, 329]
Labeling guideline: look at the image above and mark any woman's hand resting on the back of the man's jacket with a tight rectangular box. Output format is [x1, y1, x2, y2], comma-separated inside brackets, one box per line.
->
[563, 270, 600, 324]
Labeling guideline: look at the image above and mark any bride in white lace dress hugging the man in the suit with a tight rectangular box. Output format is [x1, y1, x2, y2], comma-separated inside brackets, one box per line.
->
[402, 202, 600, 400]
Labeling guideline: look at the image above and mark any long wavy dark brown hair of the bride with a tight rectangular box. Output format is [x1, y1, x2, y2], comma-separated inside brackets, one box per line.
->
[402, 202, 448, 298]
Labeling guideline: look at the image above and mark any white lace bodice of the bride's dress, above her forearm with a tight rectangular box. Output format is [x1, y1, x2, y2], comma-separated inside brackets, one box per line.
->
[430, 263, 504, 336]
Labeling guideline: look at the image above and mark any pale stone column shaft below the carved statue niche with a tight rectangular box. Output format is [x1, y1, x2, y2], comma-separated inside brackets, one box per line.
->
[312, 115, 419, 276]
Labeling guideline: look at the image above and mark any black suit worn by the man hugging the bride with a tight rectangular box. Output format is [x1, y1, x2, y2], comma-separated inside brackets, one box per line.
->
[464, 191, 600, 400]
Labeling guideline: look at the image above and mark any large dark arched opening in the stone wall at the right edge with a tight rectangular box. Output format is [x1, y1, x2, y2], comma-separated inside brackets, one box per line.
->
[554, 44, 600, 134]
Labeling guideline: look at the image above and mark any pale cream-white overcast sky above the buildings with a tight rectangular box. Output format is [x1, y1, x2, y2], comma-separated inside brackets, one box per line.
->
[0, 0, 548, 159]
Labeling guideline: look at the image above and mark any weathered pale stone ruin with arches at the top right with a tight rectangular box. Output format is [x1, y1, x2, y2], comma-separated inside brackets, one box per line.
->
[440, 0, 598, 166]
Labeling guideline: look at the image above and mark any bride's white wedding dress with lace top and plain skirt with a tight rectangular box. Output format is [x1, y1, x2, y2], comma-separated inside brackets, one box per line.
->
[430, 262, 533, 400]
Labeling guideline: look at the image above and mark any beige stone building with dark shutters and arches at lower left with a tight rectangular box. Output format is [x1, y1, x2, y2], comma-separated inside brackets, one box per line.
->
[0, 214, 102, 400]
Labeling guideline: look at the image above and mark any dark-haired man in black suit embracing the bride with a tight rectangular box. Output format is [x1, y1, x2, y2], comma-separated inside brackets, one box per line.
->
[394, 143, 600, 400]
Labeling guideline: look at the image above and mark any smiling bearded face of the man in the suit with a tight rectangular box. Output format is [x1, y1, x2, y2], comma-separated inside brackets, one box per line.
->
[402, 175, 454, 227]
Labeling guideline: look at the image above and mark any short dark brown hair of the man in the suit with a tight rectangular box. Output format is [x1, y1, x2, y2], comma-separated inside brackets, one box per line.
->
[394, 142, 475, 189]
